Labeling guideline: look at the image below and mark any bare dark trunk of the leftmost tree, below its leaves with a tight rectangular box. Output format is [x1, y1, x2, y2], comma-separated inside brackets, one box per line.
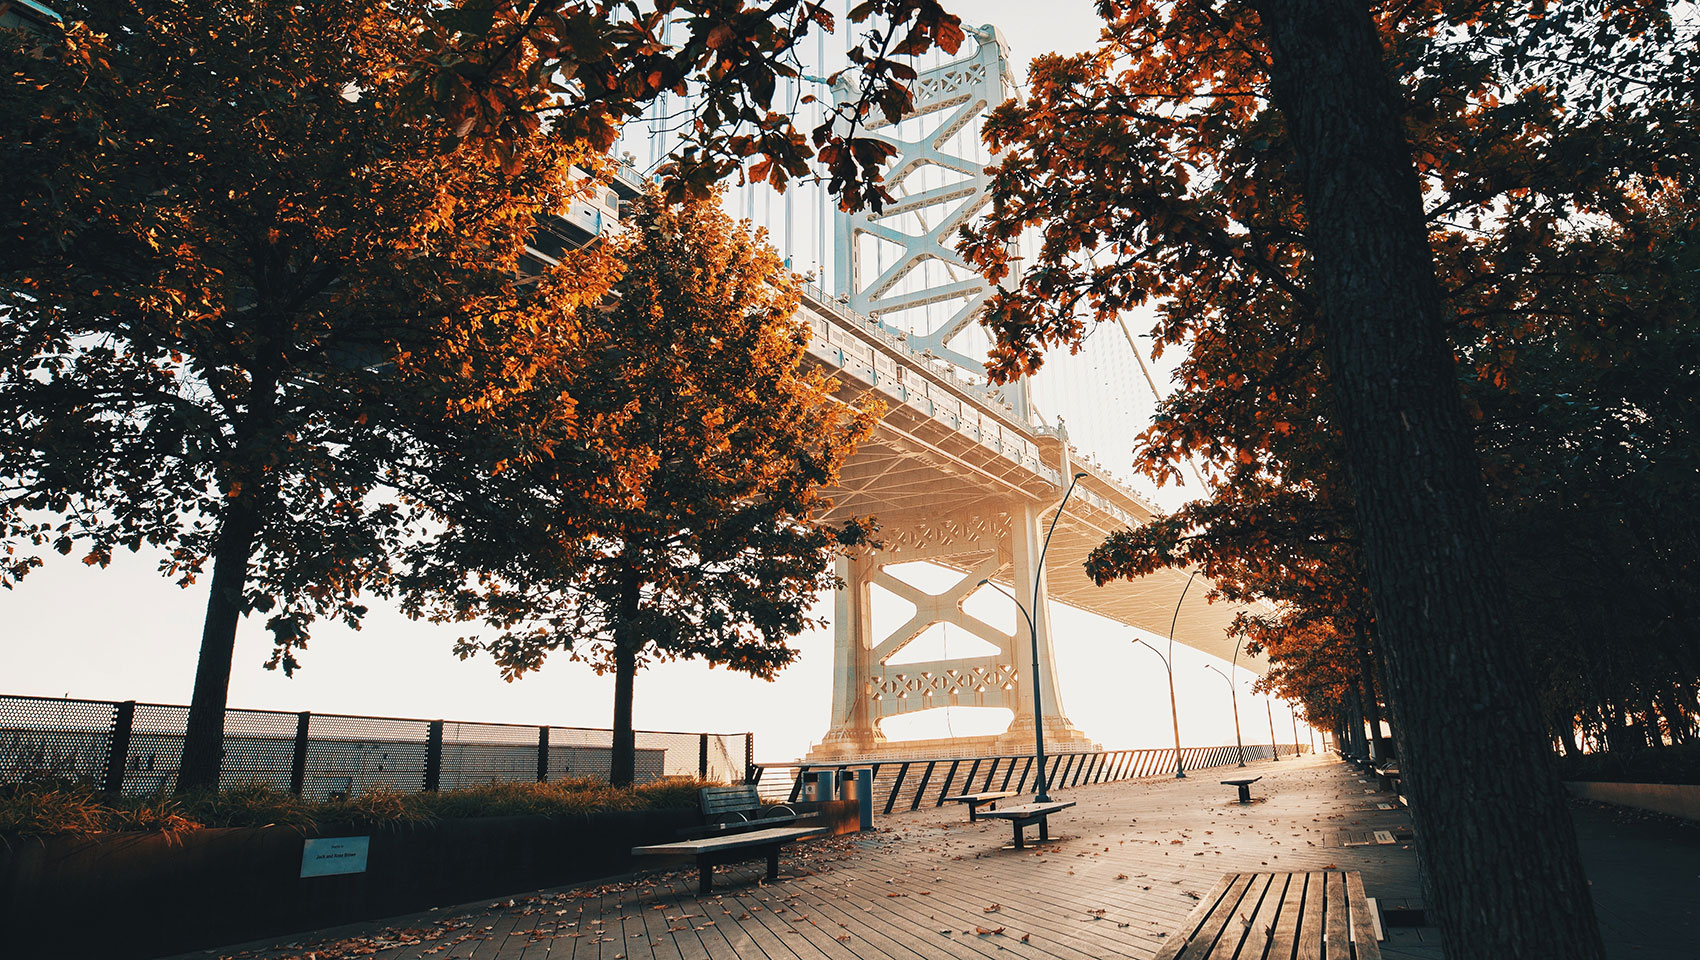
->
[177, 488, 260, 790]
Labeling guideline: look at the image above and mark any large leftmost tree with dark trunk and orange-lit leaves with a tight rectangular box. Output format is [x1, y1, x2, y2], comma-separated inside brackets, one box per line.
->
[0, 0, 612, 785]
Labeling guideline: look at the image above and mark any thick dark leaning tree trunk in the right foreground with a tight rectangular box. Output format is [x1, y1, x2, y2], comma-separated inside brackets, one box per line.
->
[1258, 0, 1603, 960]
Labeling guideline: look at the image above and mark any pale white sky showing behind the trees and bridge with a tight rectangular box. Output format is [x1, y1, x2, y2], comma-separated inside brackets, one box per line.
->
[0, 0, 1306, 761]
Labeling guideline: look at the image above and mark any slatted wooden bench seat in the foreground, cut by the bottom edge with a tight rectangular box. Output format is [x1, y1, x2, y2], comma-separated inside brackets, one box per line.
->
[1156, 870, 1380, 960]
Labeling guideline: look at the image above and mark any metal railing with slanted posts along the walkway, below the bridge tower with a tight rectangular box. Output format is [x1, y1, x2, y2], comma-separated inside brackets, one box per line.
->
[750, 744, 1309, 814]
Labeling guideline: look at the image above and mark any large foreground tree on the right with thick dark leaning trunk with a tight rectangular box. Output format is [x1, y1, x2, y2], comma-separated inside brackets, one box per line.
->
[964, 2, 1697, 957]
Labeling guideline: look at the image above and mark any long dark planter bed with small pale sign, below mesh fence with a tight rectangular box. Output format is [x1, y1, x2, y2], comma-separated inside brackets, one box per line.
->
[0, 800, 857, 960]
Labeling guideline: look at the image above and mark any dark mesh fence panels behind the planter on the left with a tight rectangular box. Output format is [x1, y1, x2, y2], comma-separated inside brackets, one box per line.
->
[0, 697, 755, 800]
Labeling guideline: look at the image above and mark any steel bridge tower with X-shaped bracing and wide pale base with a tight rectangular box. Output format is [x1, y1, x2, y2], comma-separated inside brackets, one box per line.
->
[809, 25, 1097, 761]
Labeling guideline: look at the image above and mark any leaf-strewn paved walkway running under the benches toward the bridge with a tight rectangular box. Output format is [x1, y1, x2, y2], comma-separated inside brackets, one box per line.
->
[184, 758, 1700, 960]
